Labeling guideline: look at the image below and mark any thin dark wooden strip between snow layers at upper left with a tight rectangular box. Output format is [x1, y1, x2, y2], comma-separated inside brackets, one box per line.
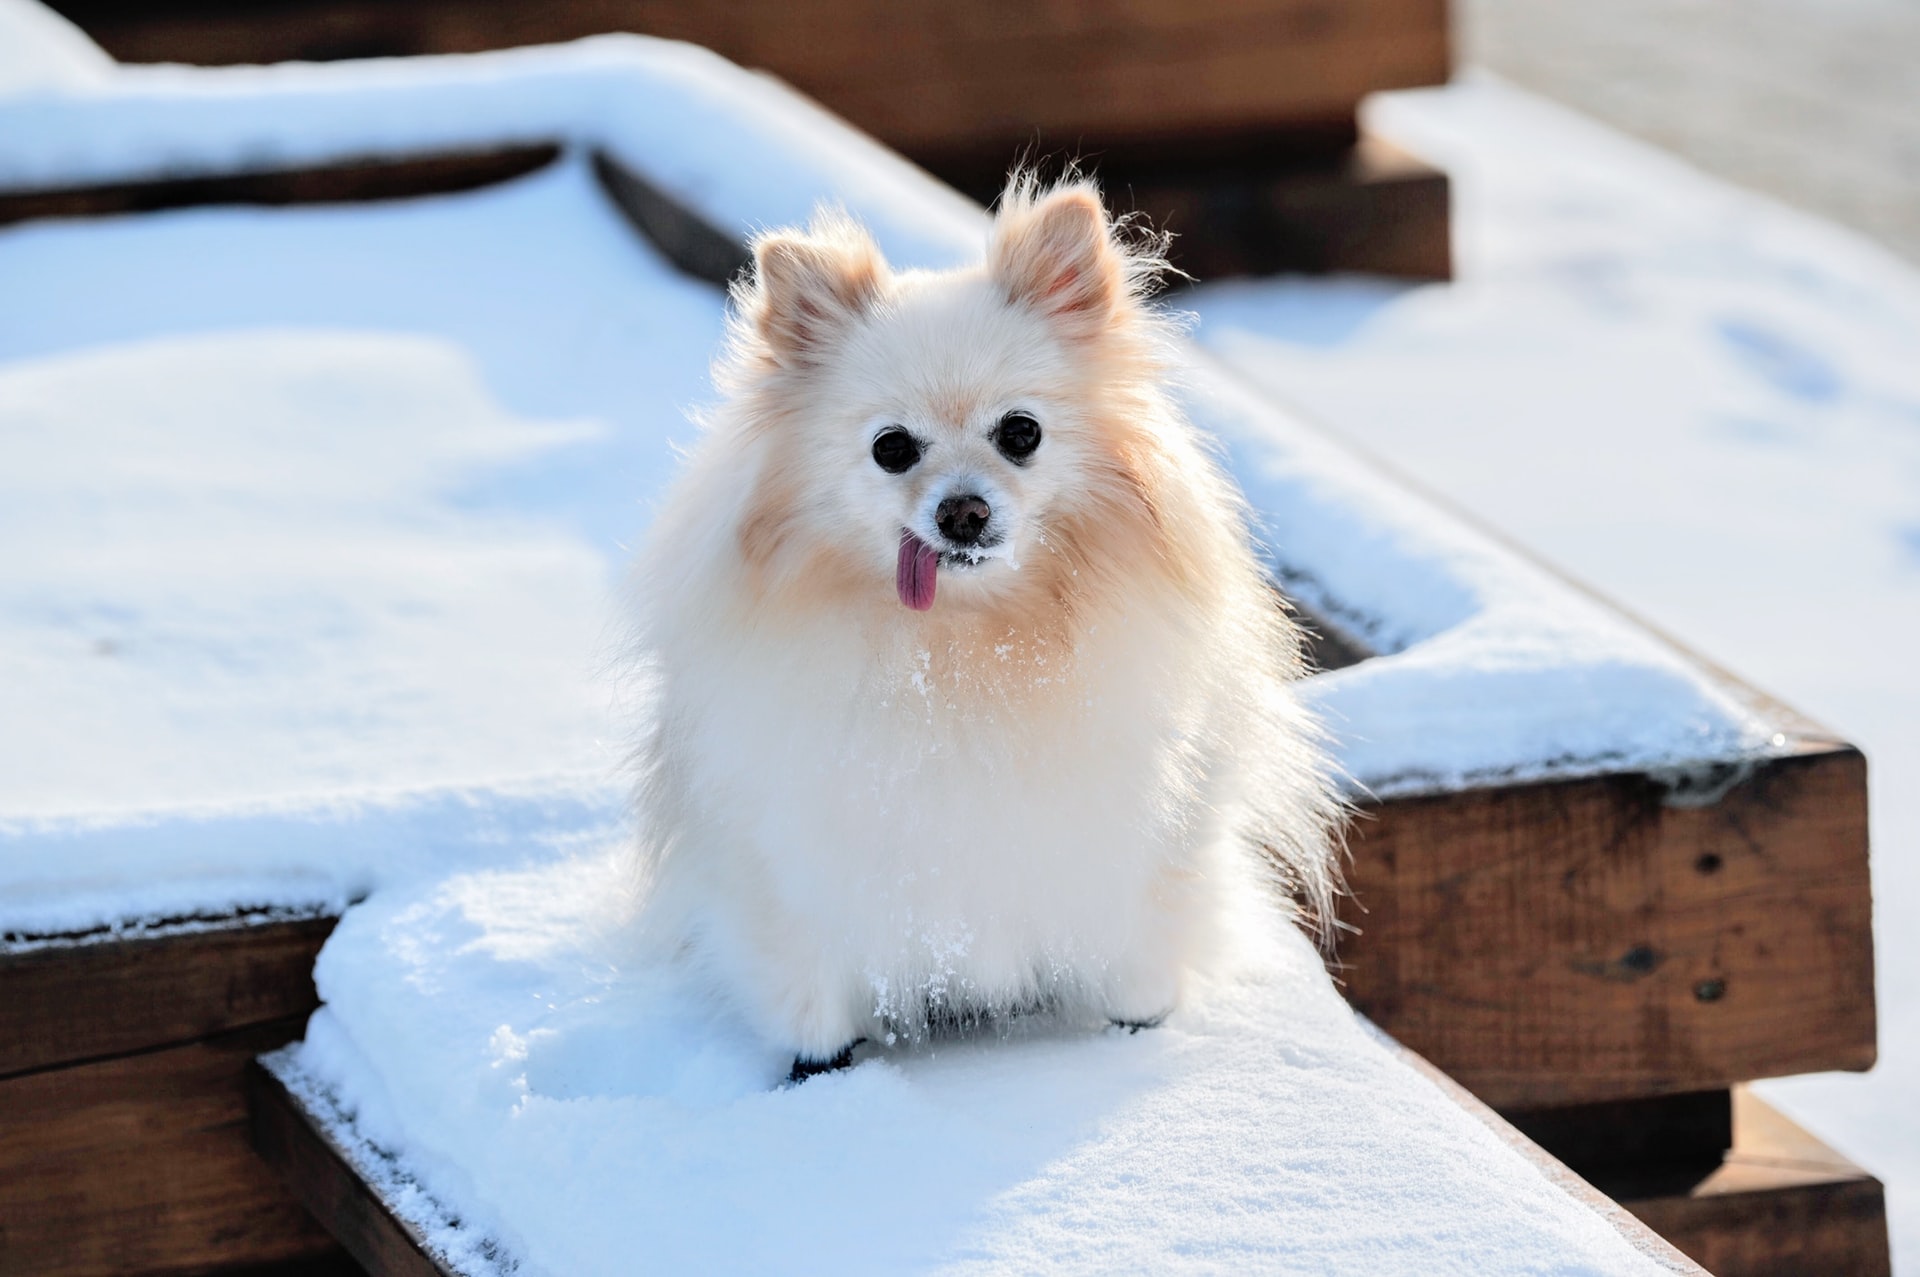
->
[0, 142, 561, 225]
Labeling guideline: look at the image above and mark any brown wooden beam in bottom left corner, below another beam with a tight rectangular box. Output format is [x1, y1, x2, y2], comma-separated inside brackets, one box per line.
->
[0, 1018, 336, 1277]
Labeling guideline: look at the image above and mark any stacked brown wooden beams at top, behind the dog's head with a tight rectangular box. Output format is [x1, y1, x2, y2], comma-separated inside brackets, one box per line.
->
[41, 0, 1452, 278]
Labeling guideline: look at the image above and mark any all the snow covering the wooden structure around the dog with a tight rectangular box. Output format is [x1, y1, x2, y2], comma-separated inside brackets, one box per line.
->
[0, 17, 1889, 1273]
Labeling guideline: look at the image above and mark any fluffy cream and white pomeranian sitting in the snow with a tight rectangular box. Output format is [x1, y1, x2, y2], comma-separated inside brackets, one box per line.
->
[636, 179, 1340, 1081]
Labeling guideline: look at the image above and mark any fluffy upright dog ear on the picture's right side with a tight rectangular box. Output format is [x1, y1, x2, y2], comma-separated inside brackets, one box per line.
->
[987, 182, 1127, 336]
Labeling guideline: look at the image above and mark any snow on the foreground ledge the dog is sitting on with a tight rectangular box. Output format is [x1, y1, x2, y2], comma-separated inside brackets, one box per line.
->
[276, 855, 1663, 1277]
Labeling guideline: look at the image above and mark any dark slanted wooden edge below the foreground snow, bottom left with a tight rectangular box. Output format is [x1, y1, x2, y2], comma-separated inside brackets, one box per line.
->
[246, 1052, 482, 1277]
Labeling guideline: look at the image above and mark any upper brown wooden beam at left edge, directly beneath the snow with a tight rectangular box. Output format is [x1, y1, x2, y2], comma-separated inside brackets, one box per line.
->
[0, 914, 336, 1077]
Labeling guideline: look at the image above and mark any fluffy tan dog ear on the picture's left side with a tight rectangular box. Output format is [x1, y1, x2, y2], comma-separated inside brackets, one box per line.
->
[747, 219, 887, 367]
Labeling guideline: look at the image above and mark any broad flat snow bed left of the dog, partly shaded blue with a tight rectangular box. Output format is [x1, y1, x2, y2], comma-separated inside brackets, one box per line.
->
[0, 163, 706, 933]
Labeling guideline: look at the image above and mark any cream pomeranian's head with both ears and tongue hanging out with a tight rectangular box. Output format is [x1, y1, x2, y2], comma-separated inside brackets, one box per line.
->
[743, 190, 1140, 611]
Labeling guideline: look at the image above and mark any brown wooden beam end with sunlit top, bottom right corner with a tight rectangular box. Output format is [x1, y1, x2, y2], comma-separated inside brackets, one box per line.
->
[1620, 1087, 1893, 1277]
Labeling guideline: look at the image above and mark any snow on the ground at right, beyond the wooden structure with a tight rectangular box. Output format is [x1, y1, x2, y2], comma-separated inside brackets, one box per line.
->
[1188, 79, 1920, 1271]
